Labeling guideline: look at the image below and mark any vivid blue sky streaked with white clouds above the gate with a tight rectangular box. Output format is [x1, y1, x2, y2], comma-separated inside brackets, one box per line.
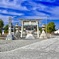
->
[0, 0, 59, 27]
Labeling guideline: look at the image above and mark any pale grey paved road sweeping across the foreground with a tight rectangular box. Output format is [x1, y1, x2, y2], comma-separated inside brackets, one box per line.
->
[0, 37, 59, 59]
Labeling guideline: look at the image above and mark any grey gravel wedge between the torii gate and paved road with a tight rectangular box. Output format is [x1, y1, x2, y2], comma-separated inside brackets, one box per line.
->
[0, 39, 41, 52]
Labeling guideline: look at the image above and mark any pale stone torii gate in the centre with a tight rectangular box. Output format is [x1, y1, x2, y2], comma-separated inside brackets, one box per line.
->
[21, 19, 39, 38]
